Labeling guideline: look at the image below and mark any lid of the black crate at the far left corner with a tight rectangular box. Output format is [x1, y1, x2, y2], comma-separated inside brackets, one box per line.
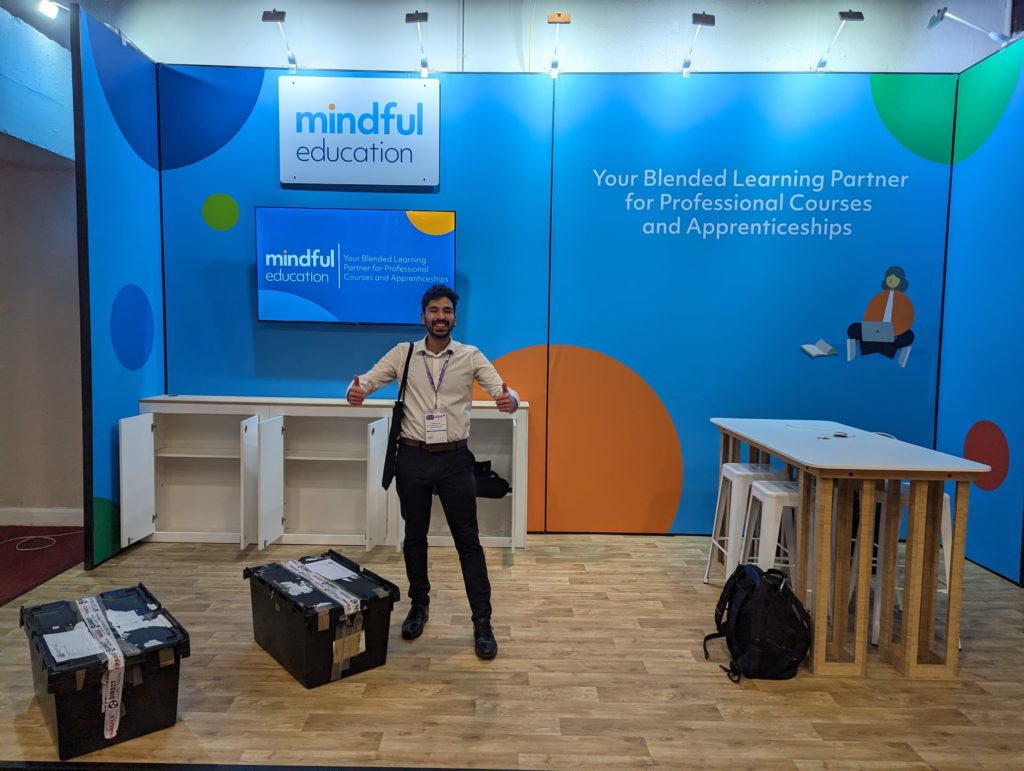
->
[20, 584, 188, 680]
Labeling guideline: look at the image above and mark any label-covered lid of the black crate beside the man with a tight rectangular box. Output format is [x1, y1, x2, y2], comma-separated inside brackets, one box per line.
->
[243, 550, 398, 615]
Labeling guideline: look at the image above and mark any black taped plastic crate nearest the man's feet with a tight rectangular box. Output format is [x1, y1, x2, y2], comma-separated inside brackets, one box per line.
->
[243, 550, 399, 688]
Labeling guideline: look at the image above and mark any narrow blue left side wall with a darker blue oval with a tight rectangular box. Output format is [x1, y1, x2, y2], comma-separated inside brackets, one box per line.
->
[72, 12, 164, 566]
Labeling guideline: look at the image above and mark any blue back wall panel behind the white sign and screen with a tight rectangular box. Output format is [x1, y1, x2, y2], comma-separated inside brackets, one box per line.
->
[159, 66, 552, 400]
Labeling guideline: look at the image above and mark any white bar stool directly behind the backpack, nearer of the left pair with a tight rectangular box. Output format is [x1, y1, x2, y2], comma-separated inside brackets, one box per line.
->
[740, 479, 800, 570]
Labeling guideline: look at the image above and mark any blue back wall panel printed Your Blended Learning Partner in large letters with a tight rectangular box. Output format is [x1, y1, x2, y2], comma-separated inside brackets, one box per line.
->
[547, 74, 955, 533]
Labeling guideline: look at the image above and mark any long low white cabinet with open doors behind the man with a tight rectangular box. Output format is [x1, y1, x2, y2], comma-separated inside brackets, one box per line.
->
[120, 395, 528, 549]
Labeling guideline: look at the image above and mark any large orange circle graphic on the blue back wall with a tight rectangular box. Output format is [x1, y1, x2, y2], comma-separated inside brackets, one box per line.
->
[476, 345, 683, 532]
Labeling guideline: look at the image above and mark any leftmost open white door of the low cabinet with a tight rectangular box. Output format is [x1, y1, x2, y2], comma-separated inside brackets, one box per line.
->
[118, 414, 157, 549]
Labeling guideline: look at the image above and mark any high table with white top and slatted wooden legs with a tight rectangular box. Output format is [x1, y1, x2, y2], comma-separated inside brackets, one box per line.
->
[711, 418, 990, 678]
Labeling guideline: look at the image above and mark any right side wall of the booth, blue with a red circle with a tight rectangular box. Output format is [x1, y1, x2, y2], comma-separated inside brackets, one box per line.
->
[937, 42, 1024, 583]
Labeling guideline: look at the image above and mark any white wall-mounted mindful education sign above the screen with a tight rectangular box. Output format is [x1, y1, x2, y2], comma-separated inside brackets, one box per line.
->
[278, 76, 440, 187]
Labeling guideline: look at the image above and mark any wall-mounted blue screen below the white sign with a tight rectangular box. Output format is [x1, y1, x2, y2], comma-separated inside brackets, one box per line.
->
[256, 207, 455, 324]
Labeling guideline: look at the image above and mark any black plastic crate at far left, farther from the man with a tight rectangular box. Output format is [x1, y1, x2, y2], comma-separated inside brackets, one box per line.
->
[20, 584, 188, 760]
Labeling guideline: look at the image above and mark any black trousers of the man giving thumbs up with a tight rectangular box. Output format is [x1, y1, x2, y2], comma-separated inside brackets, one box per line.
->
[395, 444, 490, 622]
